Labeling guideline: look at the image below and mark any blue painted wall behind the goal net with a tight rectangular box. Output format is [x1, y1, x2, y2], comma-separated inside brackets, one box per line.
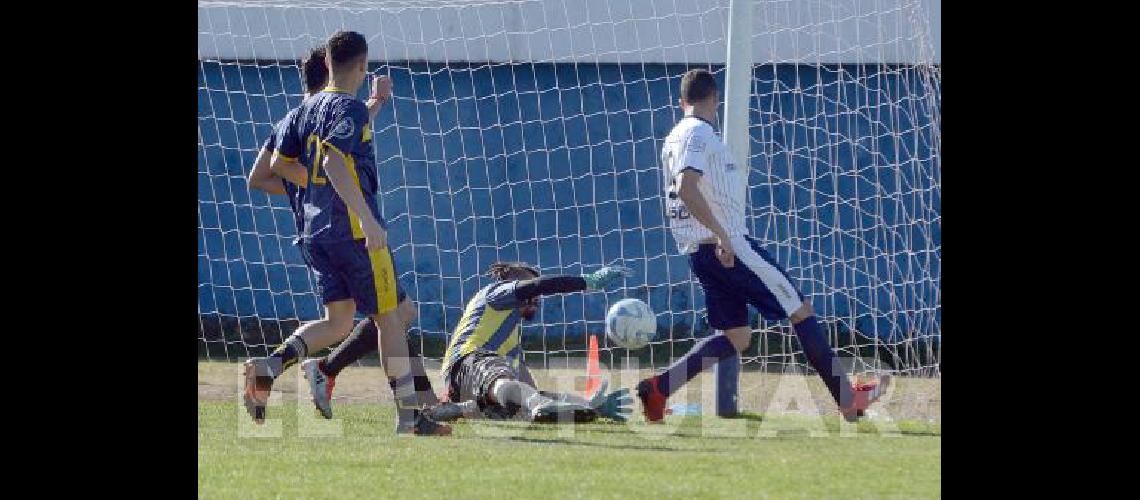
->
[198, 62, 942, 336]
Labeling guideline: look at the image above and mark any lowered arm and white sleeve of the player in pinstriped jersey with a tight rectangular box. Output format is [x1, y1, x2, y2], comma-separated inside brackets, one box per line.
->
[671, 133, 735, 268]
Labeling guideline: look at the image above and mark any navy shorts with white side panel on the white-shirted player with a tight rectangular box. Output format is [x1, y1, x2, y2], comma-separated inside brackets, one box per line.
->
[689, 236, 804, 330]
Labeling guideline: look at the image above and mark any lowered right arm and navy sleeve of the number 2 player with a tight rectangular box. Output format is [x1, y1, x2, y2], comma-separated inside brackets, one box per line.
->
[321, 101, 388, 248]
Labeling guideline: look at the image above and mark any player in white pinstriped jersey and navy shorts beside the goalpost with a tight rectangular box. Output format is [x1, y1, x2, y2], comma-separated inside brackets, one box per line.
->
[637, 69, 890, 421]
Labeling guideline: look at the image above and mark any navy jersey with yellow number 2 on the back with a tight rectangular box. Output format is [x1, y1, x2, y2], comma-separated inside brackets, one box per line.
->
[277, 88, 384, 241]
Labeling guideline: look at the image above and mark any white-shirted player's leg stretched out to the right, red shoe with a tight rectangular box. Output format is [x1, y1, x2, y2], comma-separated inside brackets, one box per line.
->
[733, 237, 889, 419]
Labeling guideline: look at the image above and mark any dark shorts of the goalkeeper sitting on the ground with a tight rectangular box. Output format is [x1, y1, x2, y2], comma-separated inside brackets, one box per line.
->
[447, 350, 520, 419]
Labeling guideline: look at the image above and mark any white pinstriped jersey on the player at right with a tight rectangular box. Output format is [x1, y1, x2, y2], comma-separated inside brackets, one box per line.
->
[661, 116, 748, 254]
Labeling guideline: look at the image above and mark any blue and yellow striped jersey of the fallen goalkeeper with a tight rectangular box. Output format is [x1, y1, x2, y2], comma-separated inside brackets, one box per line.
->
[441, 281, 523, 378]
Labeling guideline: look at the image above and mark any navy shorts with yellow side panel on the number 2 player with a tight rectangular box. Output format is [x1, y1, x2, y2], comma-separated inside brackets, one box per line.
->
[301, 239, 406, 315]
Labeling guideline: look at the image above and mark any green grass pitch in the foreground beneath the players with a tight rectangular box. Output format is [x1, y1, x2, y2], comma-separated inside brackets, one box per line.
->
[198, 363, 942, 499]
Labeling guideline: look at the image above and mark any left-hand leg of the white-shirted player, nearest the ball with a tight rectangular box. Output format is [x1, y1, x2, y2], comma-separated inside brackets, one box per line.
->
[637, 245, 752, 421]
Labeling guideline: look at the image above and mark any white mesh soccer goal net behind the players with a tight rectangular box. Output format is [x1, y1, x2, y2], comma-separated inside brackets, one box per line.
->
[197, 0, 942, 377]
